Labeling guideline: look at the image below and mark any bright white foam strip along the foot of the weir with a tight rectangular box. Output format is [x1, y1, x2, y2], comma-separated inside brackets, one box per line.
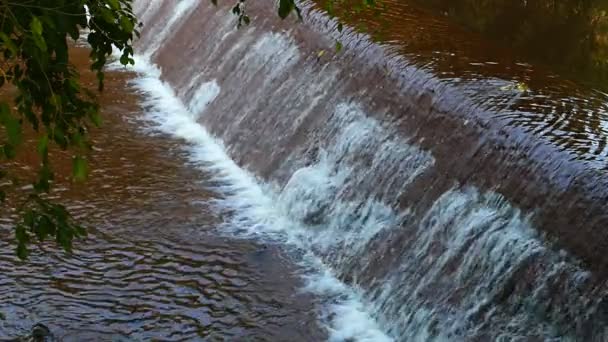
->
[128, 57, 391, 342]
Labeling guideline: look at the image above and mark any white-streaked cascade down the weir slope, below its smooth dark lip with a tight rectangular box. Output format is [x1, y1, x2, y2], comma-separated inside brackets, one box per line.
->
[124, 0, 608, 341]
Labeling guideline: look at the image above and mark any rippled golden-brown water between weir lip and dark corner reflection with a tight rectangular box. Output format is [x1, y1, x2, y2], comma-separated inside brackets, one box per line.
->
[326, 0, 608, 170]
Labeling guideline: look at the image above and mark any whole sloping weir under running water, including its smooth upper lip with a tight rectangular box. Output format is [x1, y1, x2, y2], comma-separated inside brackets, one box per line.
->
[131, 0, 608, 341]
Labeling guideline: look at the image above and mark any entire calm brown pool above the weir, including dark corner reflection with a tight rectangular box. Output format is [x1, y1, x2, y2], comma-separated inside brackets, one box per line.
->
[330, 0, 608, 169]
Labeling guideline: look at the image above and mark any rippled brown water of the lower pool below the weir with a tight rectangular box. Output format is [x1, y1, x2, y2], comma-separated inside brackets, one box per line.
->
[0, 50, 324, 341]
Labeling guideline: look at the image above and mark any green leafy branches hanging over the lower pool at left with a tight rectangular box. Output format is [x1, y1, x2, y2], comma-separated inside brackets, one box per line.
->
[0, 0, 139, 258]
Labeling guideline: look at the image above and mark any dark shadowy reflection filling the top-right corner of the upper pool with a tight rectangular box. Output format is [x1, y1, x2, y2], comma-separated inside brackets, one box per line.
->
[419, 0, 608, 89]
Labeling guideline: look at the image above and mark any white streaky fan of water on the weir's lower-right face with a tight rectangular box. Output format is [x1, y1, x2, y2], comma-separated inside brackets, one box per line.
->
[368, 187, 590, 341]
